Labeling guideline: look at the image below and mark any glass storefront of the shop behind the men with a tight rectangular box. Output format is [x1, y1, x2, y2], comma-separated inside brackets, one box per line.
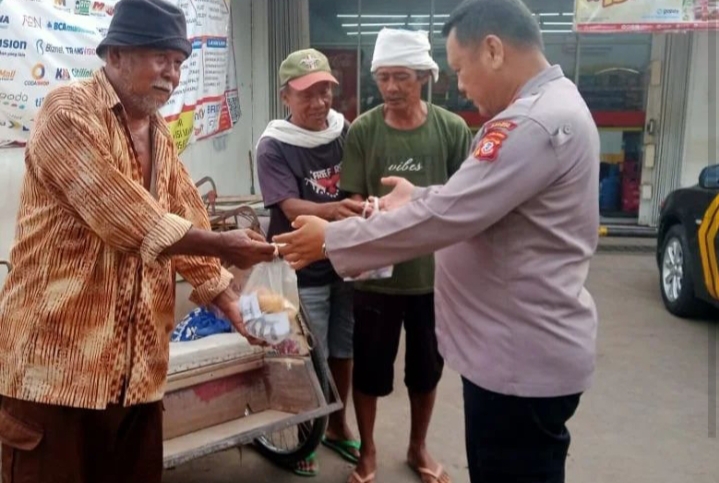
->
[309, 0, 651, 216]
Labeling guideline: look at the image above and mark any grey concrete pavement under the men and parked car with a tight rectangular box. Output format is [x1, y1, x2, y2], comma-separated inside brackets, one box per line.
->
[164, 252, 719, 483]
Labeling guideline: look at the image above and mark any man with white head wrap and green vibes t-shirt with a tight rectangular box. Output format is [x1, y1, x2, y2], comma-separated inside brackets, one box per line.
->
[340, 29, 472, 483]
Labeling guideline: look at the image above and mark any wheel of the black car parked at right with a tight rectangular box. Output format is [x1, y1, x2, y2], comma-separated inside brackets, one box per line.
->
[659, 225, 706, 317]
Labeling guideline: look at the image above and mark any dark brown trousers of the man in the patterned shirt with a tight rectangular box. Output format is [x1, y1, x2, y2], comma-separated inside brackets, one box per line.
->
[0, 397, 162, 483]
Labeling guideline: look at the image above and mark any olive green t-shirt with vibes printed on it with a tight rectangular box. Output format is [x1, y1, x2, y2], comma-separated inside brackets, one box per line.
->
[340, 104, 472, 295]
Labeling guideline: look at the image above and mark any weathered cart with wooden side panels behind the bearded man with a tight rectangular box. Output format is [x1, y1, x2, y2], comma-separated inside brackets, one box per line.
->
[164, 177, 342, 468]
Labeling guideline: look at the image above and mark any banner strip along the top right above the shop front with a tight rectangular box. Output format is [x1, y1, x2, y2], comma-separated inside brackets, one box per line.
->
[574, 0, 719, 33]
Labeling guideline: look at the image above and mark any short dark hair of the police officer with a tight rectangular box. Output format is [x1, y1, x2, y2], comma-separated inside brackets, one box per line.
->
[442, 0, 544, 50]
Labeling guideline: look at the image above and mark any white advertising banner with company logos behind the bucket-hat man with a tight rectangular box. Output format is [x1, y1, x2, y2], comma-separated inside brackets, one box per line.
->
[0, 0, 240, 151]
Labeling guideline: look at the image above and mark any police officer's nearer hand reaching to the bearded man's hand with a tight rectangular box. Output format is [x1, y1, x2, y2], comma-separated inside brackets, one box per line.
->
[273, 216, 329, 270]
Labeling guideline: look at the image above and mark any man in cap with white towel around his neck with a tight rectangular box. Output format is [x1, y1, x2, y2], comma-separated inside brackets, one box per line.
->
[257, 49, 363, 476]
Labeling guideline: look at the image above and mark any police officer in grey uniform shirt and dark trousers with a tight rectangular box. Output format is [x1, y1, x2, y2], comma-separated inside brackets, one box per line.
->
[276, 0, 599, 483]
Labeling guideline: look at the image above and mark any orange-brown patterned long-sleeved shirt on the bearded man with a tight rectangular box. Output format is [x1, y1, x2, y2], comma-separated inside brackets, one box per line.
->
[0, 70, 232, 409]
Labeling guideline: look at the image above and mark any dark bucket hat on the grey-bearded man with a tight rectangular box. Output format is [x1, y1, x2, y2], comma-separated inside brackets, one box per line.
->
[96, 0, 192, 57]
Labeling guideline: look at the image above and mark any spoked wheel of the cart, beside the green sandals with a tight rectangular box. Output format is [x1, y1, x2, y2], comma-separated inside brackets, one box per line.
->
[255, 336, 330, 467]
